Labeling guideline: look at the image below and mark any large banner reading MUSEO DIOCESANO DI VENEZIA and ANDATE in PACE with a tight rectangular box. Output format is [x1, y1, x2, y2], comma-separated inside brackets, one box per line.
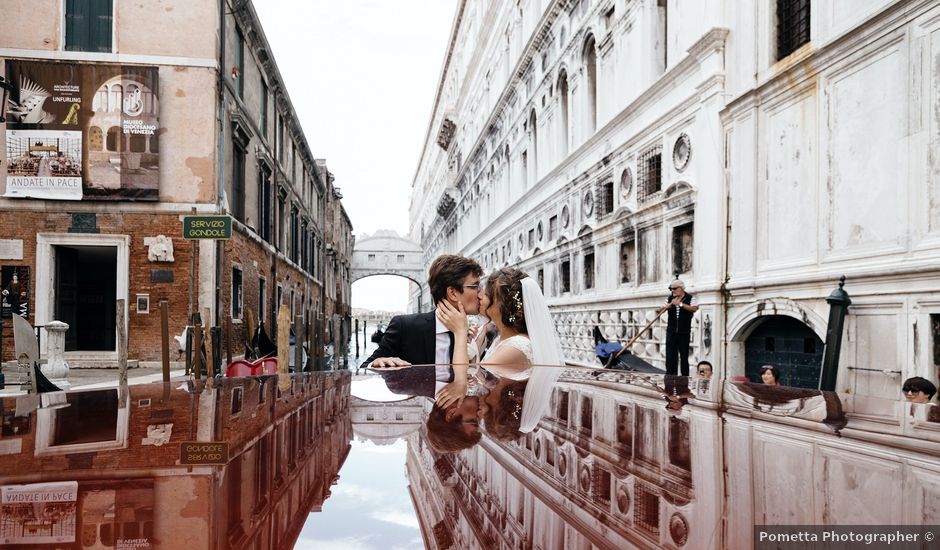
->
[4, 60, 160, 200]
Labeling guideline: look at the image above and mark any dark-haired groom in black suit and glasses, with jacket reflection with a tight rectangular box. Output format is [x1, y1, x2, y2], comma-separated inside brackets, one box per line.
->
[361, 255, 483, 399]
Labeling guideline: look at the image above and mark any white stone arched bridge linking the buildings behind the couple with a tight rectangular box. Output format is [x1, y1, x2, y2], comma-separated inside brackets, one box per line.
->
[352, 230, 427, 311]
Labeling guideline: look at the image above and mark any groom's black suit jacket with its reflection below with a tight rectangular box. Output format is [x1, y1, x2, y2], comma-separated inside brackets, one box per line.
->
[361, 312, 453, 397]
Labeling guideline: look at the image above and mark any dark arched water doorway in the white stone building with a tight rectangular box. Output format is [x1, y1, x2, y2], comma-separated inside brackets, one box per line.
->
[744, 315, 823, 389]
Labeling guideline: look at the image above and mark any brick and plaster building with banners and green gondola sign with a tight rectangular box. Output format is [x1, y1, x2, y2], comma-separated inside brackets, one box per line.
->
[0, 0, 353, 370]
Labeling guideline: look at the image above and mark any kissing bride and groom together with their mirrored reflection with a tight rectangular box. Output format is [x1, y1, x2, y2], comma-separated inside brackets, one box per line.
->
[362, 255, 564, 452]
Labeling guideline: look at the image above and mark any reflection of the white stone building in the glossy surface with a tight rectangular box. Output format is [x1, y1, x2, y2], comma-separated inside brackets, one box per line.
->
[407, 371, 940, 550]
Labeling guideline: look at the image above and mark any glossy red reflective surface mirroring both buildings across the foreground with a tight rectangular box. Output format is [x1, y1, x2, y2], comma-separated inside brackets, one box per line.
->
[0, 364, 940, 550]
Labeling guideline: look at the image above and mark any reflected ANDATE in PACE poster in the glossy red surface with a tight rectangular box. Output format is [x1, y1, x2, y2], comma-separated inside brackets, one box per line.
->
[0, 481, 78, 545]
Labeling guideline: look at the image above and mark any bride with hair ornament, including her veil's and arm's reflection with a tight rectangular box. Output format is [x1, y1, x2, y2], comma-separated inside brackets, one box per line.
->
[437, 267, 564, 433]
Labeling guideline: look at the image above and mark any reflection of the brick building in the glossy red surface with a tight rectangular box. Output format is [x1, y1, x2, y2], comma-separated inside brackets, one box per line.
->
[0, 373, 353, 549]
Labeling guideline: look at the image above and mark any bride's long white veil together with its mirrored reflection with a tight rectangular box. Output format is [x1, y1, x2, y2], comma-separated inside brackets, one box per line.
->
[519, 277, 565, 433]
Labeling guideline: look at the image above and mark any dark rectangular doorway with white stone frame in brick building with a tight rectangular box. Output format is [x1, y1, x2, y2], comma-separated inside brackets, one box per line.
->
[55, 246, 117, 351]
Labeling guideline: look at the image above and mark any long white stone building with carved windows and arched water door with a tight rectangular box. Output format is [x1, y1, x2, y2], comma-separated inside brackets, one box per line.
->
[411, 0, 940, 406]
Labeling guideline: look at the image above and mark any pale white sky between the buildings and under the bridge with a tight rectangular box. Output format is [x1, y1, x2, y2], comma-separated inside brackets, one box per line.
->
[253, 0, 457, 311]
